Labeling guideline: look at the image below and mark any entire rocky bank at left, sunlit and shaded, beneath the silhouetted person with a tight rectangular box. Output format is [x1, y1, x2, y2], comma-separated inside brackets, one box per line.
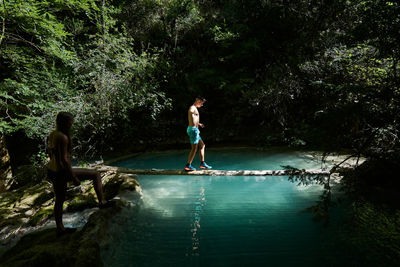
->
[0, 172, 140, 267]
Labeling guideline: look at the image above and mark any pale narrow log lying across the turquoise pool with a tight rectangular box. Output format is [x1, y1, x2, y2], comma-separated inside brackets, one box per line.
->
[97, 165, 329, 176]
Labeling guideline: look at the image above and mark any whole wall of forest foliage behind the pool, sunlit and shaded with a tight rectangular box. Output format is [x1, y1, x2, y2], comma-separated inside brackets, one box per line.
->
[0, 0, 400, 161]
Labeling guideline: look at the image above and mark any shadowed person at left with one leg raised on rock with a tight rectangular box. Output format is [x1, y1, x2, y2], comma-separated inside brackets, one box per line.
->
[47, 112, 115, 235]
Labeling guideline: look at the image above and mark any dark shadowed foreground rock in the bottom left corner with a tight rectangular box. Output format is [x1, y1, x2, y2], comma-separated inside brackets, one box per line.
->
[0, 201, 124, 267]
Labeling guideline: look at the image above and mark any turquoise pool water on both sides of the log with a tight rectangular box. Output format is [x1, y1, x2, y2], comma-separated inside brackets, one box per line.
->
[102, 149, 337, 266]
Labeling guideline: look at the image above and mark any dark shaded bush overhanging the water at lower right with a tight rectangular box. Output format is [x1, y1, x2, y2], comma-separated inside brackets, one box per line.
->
[282, 156, 400, 266]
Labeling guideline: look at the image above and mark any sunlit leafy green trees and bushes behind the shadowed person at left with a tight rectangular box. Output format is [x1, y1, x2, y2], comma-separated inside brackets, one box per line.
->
[0, 0, 168, 156]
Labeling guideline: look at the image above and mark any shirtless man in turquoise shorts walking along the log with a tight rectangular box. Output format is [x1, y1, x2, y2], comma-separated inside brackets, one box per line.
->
[185, 96, 212, 171]
